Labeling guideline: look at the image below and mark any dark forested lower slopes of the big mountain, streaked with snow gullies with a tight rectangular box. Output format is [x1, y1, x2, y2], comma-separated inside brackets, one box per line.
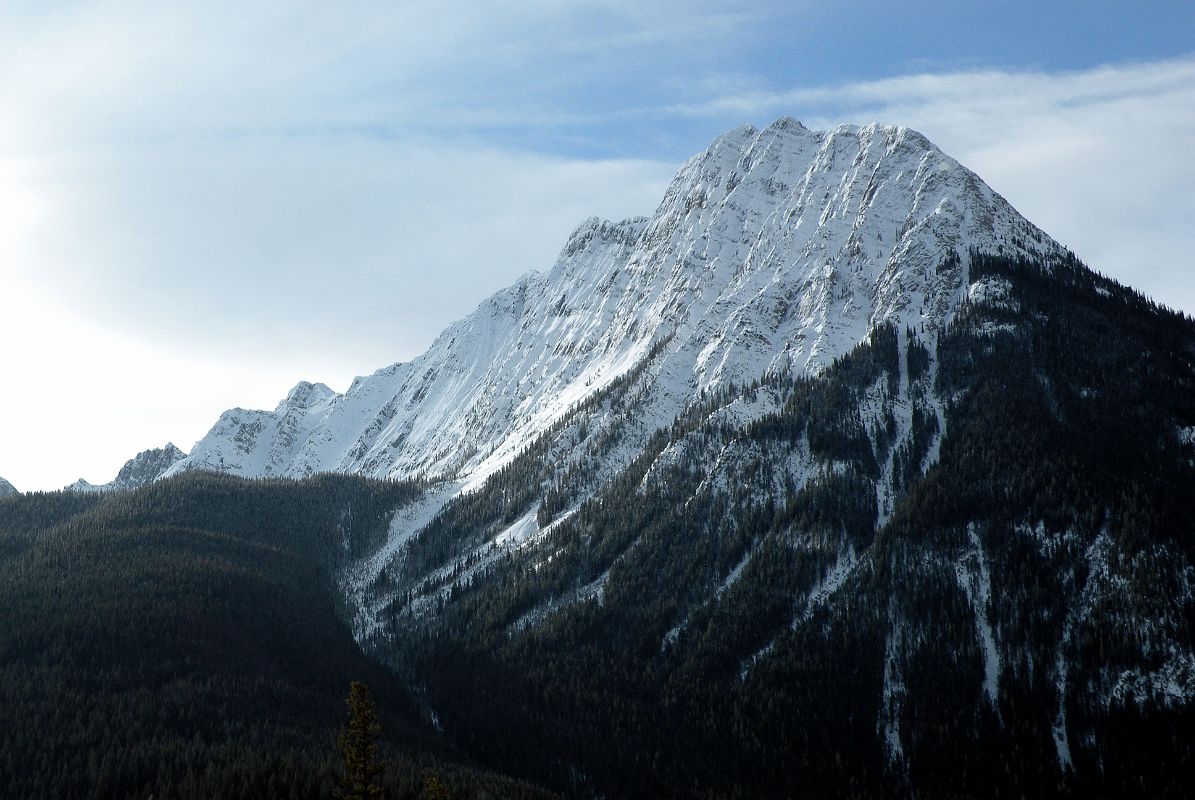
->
[359, 254, 1195, 798]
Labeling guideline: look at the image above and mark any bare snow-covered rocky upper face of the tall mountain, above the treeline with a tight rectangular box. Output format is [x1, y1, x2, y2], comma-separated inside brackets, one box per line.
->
[167, 117, 1061, 486]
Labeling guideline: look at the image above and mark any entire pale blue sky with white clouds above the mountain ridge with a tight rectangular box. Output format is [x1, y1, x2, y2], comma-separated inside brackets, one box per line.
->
[0, 0, 1195, 490]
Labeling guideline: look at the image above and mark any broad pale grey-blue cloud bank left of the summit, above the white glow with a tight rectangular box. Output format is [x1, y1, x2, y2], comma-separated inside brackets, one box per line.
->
[0, 138, 672, 356]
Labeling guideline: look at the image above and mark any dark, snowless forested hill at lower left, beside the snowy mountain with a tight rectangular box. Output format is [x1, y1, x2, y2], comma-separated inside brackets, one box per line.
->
[0, 475, 547, 800]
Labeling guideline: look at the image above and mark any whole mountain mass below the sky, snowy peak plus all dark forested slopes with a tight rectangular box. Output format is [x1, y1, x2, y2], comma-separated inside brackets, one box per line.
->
[0, 118, 1195, 798]
